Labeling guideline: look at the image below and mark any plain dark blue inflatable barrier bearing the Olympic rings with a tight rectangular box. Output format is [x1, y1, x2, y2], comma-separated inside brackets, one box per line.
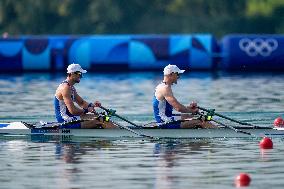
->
[221, 35, 284, 71]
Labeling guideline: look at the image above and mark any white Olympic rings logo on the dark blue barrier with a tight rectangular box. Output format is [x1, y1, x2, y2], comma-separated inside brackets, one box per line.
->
[239, 38, 278, 57]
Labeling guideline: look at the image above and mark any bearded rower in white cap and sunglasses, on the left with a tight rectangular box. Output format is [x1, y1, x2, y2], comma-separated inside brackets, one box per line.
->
[54, 64, 116, 129]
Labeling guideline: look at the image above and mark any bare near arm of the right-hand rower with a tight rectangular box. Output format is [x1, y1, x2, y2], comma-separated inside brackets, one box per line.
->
[163, 87, 192, 113]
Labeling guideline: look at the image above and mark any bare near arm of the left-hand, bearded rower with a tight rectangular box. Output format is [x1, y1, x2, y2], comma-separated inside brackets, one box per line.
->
[61, 85, 84, 116]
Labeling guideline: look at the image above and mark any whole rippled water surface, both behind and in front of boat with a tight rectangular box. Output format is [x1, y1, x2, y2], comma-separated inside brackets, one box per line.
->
[0, 73, 284, 189]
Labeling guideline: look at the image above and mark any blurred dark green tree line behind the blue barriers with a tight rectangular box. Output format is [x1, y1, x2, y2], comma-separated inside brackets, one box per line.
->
[0, 0, 284, 37]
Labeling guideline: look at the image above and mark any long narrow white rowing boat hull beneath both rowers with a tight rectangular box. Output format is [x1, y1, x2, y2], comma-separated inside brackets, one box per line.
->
[0, 123, 284, 139]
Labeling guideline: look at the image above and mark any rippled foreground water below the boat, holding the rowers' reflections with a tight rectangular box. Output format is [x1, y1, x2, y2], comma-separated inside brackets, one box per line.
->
[0, 136, 284, 189]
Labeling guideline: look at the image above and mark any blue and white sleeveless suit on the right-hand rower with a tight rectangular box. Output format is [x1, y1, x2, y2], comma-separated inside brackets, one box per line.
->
[153, 83, 180, 129]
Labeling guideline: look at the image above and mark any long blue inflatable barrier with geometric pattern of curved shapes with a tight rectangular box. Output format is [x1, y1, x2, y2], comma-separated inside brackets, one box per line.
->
[0, 34, 217, 72]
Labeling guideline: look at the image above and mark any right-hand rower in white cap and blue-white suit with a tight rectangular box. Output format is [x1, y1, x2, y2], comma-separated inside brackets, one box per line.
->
[153, 64, 215, 129]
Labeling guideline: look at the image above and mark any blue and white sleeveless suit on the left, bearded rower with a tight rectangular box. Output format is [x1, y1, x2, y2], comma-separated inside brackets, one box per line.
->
[54, 81, 81, 129]
